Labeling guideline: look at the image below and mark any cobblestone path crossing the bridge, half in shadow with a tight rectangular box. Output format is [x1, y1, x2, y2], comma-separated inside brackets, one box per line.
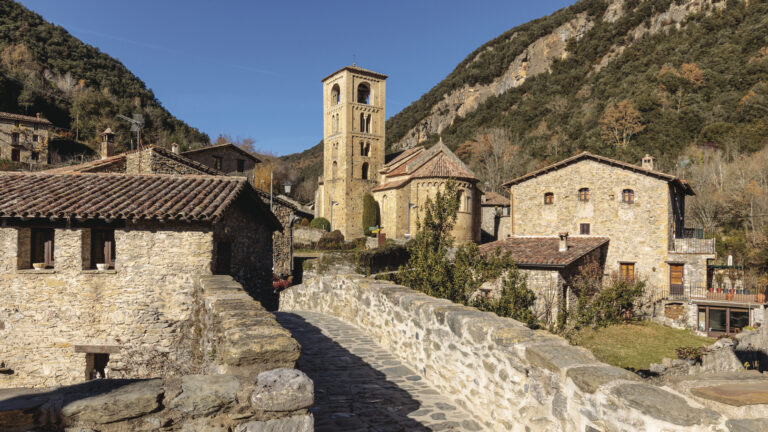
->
[277, 311, 484, 432]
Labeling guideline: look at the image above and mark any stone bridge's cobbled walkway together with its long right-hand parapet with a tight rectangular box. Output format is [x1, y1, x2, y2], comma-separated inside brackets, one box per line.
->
[277, 275, 768, 432]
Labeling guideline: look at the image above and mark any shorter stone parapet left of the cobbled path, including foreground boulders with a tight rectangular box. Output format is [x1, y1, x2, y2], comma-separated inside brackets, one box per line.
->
[0, 276, 314, 432]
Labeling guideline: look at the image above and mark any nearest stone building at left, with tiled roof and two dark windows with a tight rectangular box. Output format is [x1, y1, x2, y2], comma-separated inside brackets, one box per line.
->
[0, 173, 280, 387]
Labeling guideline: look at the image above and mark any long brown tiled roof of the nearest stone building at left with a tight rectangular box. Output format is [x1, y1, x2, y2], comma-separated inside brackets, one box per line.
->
[0, 173, 280, 229]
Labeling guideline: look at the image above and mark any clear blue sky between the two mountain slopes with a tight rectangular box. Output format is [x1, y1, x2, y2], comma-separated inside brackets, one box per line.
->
[21, 0, 574, 155]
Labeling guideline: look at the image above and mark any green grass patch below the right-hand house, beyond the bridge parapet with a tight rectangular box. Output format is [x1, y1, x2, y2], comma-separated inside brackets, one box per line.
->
[575, 323, 715, 370]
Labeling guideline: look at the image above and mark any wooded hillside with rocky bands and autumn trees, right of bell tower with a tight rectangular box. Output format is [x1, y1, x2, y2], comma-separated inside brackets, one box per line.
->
[286, 0, 768, 194]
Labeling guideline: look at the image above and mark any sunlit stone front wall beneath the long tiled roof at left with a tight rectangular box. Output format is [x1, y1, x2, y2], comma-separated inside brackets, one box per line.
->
[0, 224, 212, 388]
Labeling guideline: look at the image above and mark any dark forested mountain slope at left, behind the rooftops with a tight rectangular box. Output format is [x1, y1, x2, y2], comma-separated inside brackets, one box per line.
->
[0, 0, 209, 155]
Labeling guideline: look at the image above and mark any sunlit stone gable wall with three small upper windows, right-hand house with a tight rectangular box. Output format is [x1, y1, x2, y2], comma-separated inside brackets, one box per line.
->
[511, 160, 670, 296]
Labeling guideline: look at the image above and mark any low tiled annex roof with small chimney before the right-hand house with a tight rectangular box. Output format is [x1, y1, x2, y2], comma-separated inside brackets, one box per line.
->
[480, 237, 609, 267]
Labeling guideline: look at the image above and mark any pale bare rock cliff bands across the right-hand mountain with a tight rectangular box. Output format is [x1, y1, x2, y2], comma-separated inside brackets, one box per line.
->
[391, 0, 725, 151]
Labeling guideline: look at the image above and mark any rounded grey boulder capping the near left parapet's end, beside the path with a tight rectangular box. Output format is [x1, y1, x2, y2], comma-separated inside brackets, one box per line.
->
[251, 368, 315, 411]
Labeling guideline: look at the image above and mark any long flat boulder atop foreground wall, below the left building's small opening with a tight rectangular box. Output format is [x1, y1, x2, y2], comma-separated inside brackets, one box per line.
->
[61, 379, 164, 424]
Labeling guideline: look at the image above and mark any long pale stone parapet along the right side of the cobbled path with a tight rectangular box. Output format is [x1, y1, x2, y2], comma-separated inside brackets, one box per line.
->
[280, 275, 768, 432]
